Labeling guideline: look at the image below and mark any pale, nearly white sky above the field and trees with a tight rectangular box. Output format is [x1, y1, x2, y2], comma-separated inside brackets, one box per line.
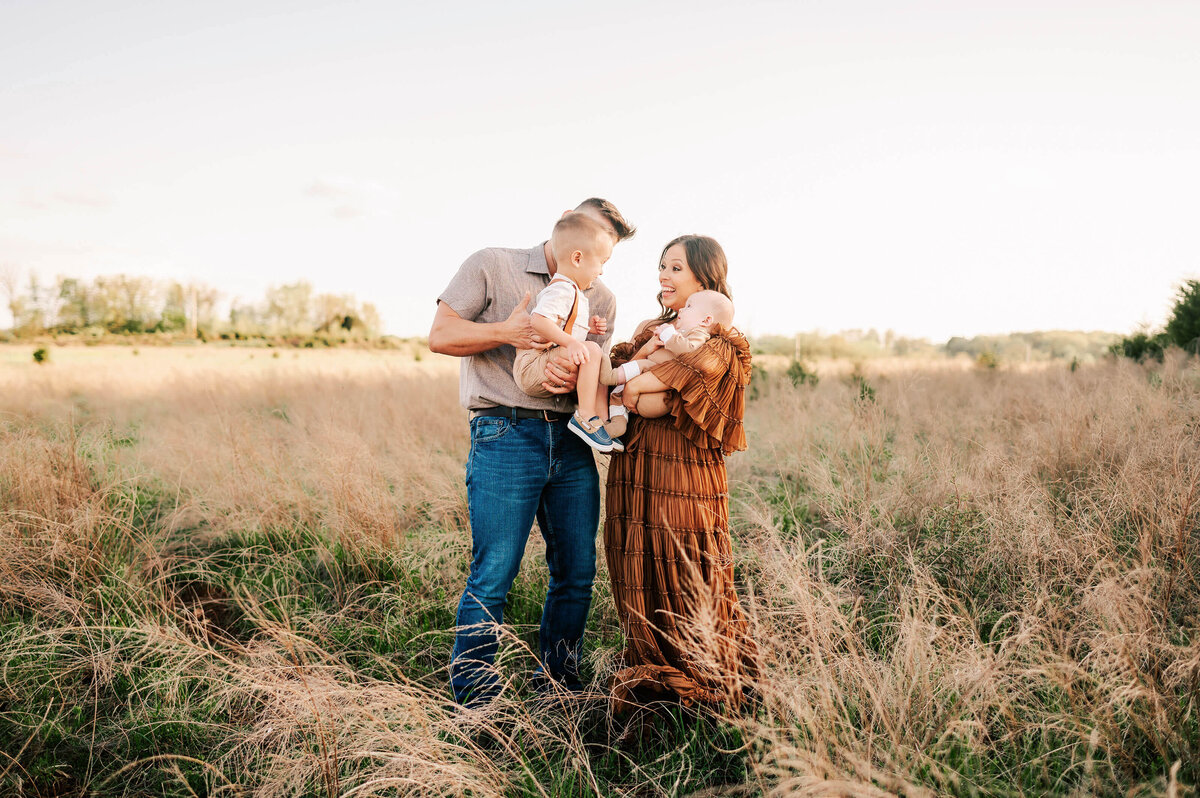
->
[0, 0, 1200, 341]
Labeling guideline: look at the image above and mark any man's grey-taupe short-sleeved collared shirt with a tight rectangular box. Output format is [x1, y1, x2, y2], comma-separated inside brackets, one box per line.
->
[438, 245, 617, 413]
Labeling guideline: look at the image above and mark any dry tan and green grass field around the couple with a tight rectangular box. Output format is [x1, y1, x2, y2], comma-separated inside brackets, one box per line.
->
[0, 347, 1200, 798]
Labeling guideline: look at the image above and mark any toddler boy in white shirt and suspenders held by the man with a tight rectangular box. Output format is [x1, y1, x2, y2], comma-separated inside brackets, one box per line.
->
[512, 214, 622, 451]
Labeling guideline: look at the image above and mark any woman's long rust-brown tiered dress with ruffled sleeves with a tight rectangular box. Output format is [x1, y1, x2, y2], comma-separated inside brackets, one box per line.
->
[604, 326, 755, 709]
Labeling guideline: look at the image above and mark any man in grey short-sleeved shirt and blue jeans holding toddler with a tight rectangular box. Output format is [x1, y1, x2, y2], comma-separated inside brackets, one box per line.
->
[430, 197, 635, 703]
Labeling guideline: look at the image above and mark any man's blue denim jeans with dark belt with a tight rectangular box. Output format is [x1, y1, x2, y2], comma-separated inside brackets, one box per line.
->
[450, 416, 600, 703]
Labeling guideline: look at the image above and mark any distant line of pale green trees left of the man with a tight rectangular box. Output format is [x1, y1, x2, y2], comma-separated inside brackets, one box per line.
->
[0, 268, 383, 340]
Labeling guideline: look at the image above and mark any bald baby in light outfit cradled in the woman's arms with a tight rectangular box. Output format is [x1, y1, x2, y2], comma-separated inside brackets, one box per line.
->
[607, 290, 733, 422]
